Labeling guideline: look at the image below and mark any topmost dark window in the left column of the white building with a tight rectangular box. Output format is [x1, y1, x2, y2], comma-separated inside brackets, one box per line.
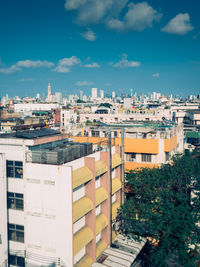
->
[6, 160, 23, 178]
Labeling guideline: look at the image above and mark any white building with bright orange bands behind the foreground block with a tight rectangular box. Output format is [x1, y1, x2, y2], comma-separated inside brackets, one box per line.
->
[72, 122, 184, 172]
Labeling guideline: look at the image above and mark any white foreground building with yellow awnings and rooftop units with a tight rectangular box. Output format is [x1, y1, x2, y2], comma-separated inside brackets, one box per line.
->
[0, 129, 121, 267]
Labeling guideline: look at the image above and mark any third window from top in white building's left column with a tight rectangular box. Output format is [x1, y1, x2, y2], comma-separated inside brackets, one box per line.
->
[8, 224, 24, 243]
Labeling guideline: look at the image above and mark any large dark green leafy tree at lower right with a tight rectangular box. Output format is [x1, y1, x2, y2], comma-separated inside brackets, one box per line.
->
[120, 154, 200, 266]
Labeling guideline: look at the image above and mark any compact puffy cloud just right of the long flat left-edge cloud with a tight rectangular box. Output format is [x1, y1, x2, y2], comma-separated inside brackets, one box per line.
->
[54, 56, 81, 73]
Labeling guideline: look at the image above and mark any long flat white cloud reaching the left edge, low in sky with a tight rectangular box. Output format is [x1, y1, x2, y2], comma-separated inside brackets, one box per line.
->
[0, 59, 54, 74]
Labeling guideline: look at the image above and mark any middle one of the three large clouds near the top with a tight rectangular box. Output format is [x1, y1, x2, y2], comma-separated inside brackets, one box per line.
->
[107, 2, 162, 31]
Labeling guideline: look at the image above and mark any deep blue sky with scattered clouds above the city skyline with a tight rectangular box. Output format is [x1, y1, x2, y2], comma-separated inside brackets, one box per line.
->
[0, 0, 200, 96]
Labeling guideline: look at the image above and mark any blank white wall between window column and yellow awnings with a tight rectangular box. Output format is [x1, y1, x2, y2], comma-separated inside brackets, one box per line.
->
[24, 163, 73, 267]
